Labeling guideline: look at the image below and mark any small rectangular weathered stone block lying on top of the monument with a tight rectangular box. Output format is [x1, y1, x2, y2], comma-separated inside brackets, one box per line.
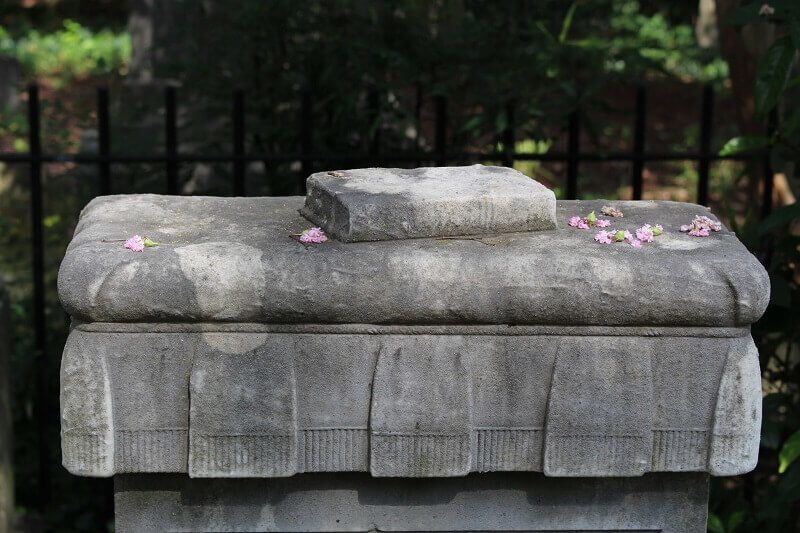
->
[302, 165, 556, 242]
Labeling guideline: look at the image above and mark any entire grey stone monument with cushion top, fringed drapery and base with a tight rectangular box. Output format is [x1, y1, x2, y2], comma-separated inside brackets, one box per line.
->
[59, 166, 769, 531]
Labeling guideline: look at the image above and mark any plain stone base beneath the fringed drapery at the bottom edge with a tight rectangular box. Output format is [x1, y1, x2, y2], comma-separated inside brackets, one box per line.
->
[115, 472, 708, 533]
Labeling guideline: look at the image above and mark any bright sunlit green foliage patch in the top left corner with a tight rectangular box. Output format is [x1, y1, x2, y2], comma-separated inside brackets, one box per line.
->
[0, 20, 131, 88]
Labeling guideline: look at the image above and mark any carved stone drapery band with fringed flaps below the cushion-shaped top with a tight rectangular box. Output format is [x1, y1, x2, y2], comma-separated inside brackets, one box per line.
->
[62, 323, 761, 477]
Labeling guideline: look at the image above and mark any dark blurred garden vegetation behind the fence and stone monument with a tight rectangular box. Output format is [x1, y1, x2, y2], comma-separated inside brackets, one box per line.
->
[0, 0, 800, 533]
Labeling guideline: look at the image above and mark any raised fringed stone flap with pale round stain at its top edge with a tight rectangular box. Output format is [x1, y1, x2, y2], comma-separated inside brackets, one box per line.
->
[189, 333, 297, 477]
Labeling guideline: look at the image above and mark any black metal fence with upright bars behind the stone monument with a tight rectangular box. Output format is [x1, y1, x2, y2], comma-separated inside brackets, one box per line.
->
[0, 86, 774, 499]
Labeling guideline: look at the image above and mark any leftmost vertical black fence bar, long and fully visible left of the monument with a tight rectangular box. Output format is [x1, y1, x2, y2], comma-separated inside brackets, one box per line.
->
[28, 85, 51, 503]
